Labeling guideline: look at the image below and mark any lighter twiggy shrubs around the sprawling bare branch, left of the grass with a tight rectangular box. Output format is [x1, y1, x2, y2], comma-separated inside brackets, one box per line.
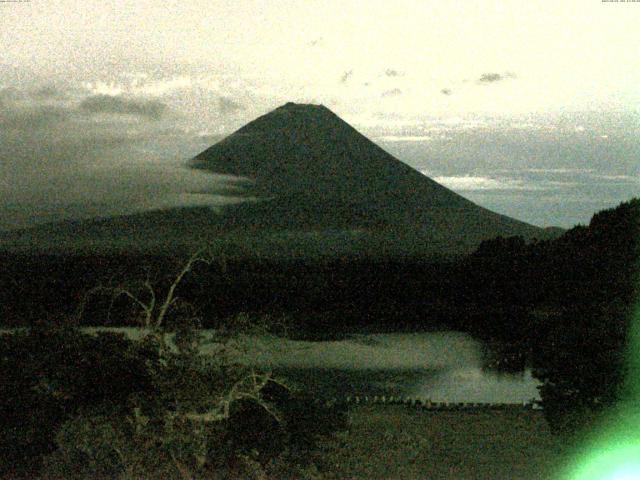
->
[31, 320, 346, 479]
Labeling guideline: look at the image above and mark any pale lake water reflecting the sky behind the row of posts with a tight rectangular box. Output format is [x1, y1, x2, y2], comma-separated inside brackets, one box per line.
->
[238, 332, 540, 403]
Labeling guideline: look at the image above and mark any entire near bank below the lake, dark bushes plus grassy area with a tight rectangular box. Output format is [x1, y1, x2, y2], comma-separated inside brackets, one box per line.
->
[0, 327, 564, 480]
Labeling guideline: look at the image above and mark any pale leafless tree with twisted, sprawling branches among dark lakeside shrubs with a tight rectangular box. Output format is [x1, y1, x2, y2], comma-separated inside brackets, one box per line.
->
[77, 248, 288, 479]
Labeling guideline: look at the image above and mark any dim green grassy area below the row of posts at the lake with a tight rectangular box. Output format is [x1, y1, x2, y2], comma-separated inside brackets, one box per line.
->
[324, 406, 566, 480]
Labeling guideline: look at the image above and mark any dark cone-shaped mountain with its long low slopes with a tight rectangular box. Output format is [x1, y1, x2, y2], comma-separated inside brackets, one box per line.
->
[3, 103, 553, 256]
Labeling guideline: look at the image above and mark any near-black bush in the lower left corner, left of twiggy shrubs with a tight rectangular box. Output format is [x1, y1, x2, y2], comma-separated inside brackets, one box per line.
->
[0, 325, 154, 475]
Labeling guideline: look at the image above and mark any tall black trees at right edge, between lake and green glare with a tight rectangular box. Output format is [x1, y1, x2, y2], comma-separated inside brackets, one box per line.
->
[530, 199, 640, 431]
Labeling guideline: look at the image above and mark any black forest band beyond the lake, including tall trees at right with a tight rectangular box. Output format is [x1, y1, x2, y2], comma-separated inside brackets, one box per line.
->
[0, 199, 640, 434]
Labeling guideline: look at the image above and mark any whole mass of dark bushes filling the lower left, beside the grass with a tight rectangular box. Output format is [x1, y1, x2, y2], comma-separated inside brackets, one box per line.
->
[0, 320, 346, 480]
